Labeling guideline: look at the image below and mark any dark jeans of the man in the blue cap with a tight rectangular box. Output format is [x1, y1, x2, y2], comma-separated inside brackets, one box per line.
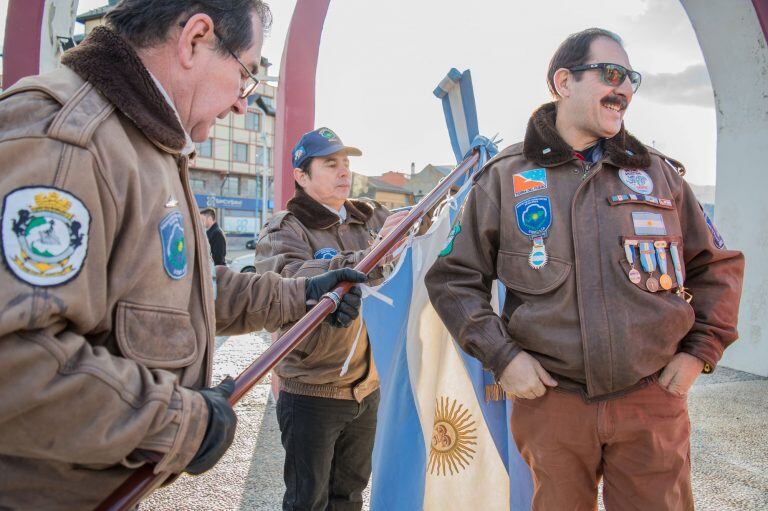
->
[277, 390, 379, 511]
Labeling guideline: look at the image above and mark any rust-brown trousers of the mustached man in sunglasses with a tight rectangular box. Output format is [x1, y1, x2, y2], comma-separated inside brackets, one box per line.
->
[511, 379, 693, 511]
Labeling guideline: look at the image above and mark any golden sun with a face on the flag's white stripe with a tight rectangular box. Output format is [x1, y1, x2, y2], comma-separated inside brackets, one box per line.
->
[427, 397, 477, 475]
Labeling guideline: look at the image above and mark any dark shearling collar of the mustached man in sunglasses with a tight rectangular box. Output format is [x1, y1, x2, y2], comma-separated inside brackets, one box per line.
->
[523, 103, 651, 169]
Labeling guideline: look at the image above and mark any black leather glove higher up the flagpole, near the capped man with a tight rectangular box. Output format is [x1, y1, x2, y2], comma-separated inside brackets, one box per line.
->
[305, 268, 368, 328]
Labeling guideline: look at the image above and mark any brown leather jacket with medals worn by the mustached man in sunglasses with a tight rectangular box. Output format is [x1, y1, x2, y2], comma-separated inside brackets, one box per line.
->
[426, 103, 744, 399]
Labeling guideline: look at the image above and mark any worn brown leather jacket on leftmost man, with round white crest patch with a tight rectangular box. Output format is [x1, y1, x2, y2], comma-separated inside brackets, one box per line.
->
[0, 28, 306, 510]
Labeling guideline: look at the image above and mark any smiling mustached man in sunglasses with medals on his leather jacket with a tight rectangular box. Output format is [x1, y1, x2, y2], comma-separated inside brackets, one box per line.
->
[426, 28, 744, 511]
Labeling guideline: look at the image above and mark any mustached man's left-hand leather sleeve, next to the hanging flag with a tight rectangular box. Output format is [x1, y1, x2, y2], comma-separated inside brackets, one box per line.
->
[425, 176, 520, 380]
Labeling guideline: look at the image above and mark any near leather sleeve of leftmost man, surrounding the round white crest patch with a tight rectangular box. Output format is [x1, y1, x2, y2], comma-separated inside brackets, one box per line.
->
[0, 136, 208, 472]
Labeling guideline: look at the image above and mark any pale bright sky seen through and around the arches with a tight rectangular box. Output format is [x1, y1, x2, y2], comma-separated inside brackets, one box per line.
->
[0, 0, 716, 185]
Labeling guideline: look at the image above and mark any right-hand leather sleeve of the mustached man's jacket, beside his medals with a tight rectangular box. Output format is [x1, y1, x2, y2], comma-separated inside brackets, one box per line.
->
[676, 179, 744, 369]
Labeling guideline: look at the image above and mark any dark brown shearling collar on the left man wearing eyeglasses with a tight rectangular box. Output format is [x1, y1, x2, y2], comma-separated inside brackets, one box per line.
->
[61, 27, 186, 152]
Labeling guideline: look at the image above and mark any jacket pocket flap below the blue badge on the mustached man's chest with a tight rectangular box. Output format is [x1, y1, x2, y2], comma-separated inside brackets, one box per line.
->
[496, 250, 571, 295]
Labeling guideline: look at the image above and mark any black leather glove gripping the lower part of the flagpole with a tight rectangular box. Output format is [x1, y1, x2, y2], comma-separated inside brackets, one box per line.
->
[184, 376, 237, 475]
